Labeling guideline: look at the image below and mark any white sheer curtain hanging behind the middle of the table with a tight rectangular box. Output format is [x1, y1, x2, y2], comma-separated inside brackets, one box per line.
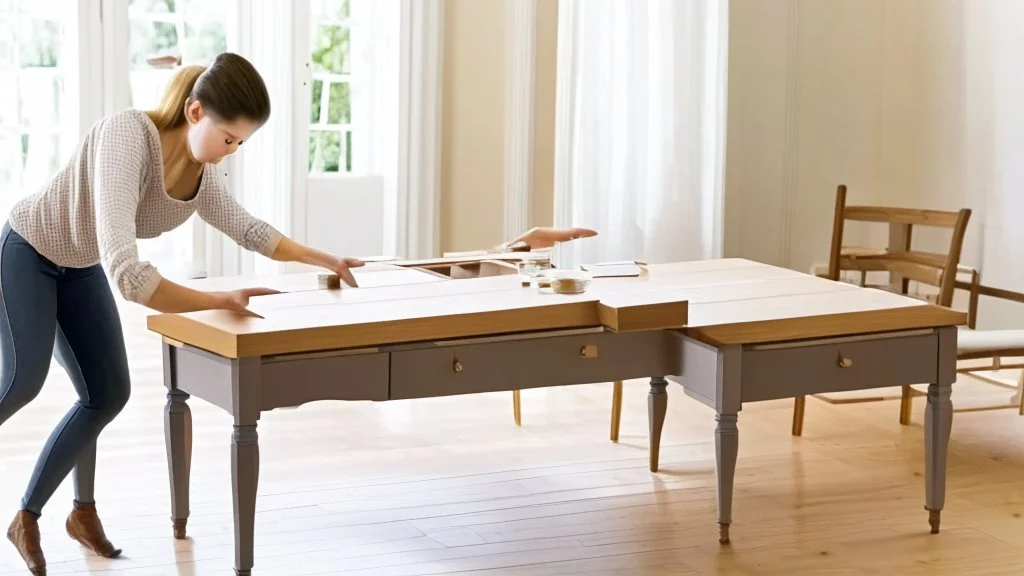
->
[555, 0, 728, 266]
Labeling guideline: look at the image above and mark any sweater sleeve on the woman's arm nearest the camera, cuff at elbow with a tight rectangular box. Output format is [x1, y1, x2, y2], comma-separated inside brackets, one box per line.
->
[92, 109, 161, 304]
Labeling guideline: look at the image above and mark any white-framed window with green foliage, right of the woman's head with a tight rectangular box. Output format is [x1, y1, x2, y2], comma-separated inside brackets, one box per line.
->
[293, 0, 406, 255]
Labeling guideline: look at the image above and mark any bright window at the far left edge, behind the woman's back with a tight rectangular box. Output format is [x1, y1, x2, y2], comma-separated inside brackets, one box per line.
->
[0, 0, 79, 219]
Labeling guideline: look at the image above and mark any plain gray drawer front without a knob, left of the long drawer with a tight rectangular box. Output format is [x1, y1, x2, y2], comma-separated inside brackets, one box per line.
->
[260, 353, 389, 410]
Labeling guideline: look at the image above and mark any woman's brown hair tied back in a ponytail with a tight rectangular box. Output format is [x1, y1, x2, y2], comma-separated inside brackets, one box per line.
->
[146, 52, 270, 130]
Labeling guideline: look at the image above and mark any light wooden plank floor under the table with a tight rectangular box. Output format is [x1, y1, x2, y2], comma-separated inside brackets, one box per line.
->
[0, 303, 1024, 576]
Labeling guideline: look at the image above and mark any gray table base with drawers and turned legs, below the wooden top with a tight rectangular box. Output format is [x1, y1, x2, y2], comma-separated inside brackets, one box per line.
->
[157, 327, 956, 576]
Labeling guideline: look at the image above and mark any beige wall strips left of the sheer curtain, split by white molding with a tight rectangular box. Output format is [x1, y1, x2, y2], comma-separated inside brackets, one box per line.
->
[440, 0, 557, 251]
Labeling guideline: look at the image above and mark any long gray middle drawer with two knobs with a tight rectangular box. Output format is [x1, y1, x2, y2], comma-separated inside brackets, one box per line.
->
[391, 332, 680, 400]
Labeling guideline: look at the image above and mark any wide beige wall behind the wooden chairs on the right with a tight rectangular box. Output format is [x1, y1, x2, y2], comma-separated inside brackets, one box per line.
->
[726, 0, 1024, 327]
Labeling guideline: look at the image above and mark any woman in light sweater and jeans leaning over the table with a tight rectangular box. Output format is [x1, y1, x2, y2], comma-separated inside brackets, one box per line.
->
[0, 53, 362, 575]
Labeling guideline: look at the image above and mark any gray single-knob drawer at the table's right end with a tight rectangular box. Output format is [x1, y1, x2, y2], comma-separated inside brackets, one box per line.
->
[740, 332, 939, 402]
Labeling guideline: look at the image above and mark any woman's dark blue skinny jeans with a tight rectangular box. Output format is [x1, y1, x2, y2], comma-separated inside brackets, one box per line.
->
[0, 223, 131, 513]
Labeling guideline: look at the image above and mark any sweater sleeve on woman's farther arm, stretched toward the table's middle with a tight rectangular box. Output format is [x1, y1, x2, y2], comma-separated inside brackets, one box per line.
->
[196, 166, 284, 258]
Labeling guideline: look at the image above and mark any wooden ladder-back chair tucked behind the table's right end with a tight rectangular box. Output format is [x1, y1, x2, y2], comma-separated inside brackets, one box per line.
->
[793, 186, 971, 436]
